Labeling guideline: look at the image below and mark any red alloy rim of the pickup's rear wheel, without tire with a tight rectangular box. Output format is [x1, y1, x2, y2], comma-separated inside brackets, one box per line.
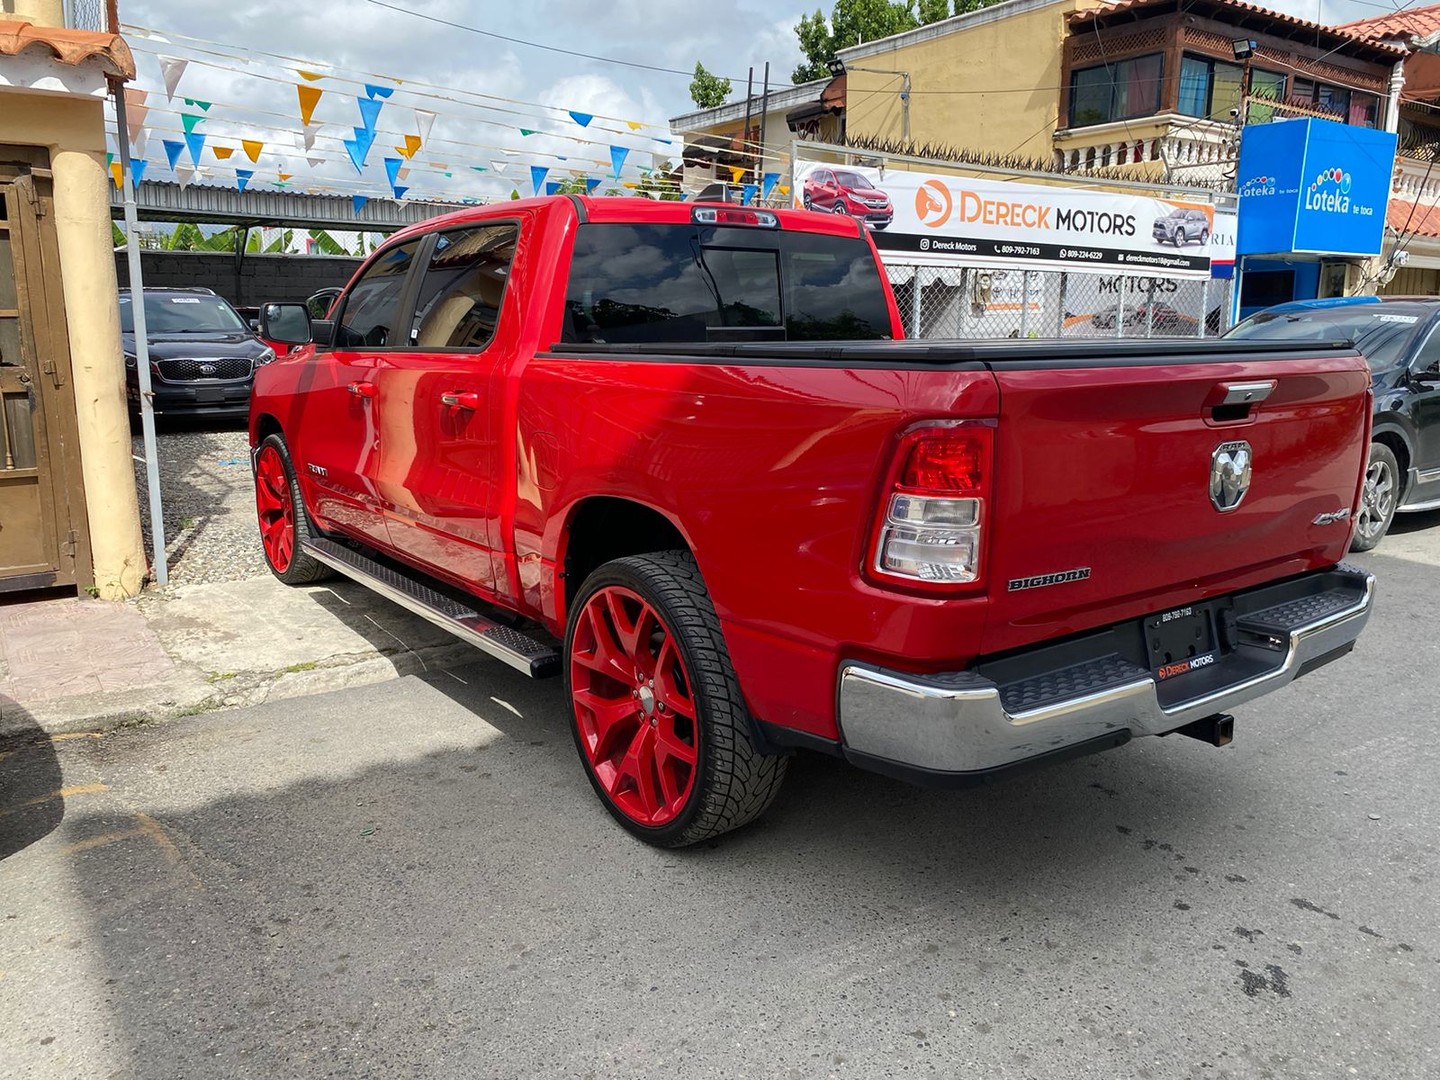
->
[570, 585, 700, 828]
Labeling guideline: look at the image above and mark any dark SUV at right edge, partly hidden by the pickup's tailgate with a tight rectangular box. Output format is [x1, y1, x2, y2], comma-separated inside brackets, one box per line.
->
[1225, 297, 1440, 552]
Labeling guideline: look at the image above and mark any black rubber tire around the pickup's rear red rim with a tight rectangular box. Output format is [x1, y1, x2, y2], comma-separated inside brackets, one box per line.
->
[564, 552, 789, 848]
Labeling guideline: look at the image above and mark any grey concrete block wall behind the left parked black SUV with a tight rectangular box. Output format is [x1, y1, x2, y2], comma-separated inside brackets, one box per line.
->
[115, 251, 360, 307]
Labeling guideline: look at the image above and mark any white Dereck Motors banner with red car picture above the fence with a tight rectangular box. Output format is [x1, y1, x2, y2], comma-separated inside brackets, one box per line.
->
[793, 163, 1233, 278]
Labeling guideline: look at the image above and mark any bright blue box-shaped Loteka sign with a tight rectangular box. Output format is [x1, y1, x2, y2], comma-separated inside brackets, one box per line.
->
[1237, 120, 1395, 255]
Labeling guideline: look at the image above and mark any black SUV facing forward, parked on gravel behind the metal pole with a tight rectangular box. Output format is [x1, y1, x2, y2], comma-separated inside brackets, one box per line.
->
[120, 288, 275, 416]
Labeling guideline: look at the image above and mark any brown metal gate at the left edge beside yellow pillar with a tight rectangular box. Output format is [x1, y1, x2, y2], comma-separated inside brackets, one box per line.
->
[0, 154, 91, 592]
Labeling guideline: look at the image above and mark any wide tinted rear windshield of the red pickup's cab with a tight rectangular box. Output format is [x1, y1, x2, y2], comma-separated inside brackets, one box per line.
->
[563, 223, 890, 344]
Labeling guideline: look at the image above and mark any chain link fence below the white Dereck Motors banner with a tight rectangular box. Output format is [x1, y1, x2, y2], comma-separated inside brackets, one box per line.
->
[886, 261, 1231, 338]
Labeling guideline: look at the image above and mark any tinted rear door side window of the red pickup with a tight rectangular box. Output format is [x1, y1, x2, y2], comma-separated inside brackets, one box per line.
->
[410, 225, 520, 348]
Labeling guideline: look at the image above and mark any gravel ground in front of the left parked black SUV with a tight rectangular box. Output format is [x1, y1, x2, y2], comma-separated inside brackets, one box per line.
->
[131, 425, 269, 585]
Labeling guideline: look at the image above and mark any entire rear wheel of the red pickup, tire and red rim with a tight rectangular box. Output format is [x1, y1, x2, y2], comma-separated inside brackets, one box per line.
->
[564, 552, 788, 848]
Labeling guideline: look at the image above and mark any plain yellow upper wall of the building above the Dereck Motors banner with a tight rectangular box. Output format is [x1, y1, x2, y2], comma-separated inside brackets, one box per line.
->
[845, 0, 1093, 161]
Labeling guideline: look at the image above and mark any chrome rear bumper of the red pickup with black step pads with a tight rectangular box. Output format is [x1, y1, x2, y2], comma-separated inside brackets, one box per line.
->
[840, 566, 1375, 783]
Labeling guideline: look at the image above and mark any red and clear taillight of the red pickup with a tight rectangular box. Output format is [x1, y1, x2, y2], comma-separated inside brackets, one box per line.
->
[870, 423, 995, 586]
